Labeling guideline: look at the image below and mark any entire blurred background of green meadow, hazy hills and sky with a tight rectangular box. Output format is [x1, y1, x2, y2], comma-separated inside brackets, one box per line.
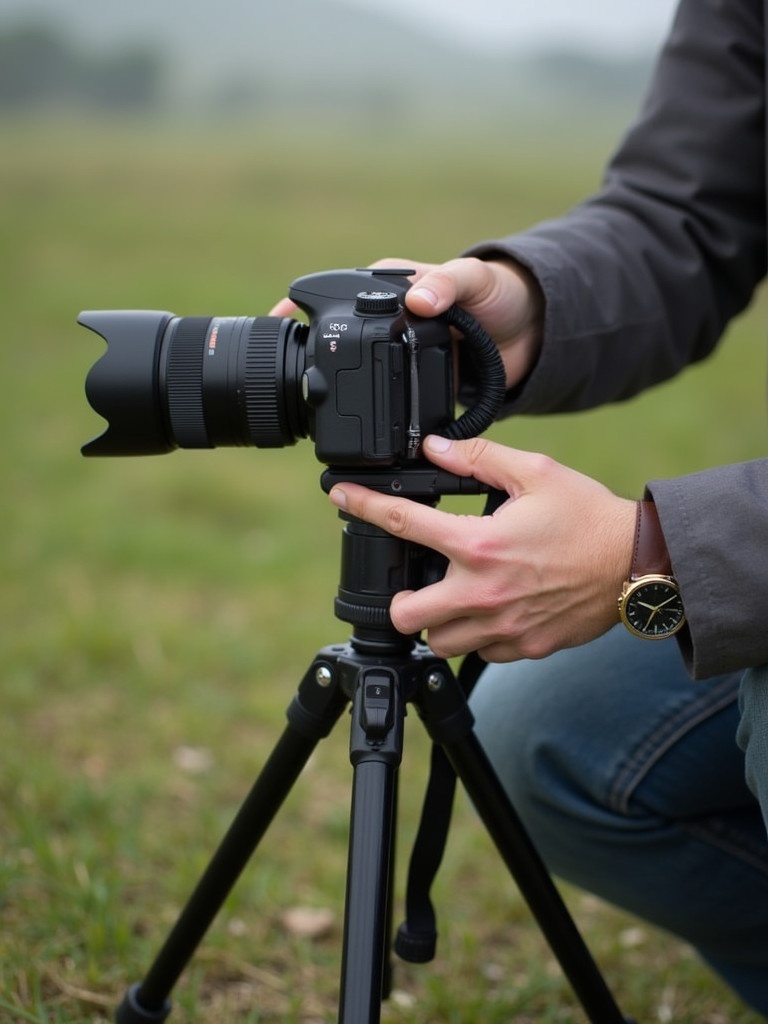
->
[0, 0, 765, 1024]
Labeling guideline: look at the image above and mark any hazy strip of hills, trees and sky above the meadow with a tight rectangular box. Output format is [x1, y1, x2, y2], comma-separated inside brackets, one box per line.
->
[0, 0, 672, 121]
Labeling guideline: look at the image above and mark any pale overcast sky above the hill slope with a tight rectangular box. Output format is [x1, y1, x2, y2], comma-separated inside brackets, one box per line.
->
[344, 0, 677, 53]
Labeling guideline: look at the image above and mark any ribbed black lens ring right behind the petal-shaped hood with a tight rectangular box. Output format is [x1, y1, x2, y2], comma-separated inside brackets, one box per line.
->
[167, 316, 212, 449]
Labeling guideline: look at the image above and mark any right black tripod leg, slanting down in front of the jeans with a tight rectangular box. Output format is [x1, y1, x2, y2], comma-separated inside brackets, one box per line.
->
[419, 666, 627, 1024]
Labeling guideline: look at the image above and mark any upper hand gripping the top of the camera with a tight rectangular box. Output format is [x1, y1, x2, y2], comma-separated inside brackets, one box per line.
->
[271, 257, 544, 387]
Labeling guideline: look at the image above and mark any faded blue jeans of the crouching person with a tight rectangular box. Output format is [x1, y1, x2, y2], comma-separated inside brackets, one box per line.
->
[471, 627, 768, 1017]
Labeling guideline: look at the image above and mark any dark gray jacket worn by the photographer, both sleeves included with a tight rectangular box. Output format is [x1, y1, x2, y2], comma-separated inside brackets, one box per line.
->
[472, 0, 768, 678]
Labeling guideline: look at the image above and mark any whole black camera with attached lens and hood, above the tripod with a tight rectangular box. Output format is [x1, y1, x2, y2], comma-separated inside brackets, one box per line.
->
[79, 269, 504, 491]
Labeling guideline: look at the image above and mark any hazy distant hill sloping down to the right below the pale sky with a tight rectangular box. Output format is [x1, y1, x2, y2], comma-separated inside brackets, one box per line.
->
[0, 0, 650, 118]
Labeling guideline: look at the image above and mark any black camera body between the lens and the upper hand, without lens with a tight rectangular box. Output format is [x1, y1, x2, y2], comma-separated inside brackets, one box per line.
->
[289, 270, 454, 467]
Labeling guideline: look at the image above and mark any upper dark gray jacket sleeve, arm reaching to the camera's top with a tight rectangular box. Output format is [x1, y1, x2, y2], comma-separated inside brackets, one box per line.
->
[469, 0, 766, 414]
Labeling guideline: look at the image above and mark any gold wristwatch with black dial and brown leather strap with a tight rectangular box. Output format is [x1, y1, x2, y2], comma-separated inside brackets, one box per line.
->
[618, 502, 685, 640]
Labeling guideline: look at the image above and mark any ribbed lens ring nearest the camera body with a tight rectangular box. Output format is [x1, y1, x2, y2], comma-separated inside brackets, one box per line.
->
[245, 316, 287, 447]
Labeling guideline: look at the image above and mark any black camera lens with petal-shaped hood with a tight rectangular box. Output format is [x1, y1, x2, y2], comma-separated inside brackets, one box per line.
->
[79, 310, 307, 456]
